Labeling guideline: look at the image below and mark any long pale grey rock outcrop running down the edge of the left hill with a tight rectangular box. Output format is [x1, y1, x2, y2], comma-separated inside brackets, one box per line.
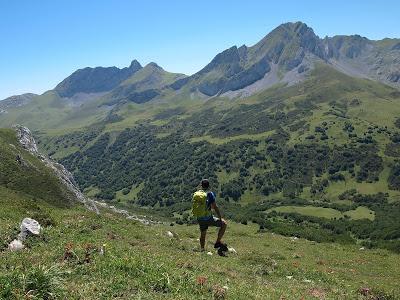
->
[13, 125, 99, 213]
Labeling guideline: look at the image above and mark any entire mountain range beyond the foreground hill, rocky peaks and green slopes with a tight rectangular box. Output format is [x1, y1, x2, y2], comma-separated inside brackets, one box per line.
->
[0, 22, 400, 253]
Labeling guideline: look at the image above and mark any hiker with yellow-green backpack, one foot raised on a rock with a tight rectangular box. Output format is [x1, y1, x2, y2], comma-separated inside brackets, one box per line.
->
[192, 179, 228, 255]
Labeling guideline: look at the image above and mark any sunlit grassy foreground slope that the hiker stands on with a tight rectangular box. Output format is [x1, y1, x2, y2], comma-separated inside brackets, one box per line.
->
[0, 196, 400, 299]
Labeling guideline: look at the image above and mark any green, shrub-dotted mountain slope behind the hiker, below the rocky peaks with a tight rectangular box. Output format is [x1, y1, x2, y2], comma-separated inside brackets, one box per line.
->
[32, 64, 400, 251]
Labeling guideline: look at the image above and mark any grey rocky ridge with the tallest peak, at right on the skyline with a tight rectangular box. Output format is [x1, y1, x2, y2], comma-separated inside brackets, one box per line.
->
[171, 22, 400, 96]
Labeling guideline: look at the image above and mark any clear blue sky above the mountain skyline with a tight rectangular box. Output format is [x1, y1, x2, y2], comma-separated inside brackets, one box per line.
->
[0, 0, 400, 99]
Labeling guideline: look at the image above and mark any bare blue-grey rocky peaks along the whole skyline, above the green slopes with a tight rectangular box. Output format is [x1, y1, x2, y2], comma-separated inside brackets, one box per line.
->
[0, 22, 400, 116]
